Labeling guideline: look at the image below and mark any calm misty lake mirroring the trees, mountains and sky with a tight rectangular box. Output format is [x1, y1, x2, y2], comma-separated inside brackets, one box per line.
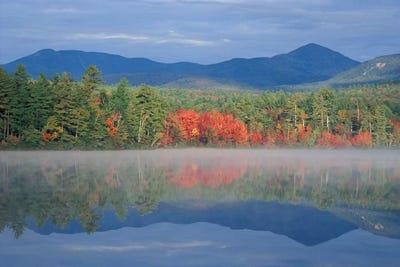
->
[0, 148, 400, 266]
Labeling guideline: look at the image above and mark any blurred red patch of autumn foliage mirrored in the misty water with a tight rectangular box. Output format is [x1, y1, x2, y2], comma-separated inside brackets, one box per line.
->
[167, 163, 247, 188]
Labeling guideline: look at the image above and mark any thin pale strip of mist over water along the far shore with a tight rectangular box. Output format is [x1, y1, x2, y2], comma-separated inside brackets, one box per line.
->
[0, 148, 400, 167]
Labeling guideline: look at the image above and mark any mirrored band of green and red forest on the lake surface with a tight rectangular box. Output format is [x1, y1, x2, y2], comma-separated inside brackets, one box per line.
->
[0, 151, 400, 237]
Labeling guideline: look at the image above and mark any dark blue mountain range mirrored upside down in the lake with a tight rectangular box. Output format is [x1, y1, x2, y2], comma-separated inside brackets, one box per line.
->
[29, 201, 357, 246]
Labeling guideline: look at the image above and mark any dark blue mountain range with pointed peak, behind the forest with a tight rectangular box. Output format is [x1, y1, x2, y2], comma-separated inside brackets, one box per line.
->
[3, 44, 359, 89]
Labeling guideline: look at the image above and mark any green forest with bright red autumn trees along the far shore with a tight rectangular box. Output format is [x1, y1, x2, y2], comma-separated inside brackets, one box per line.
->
[0, 65, 400, 149]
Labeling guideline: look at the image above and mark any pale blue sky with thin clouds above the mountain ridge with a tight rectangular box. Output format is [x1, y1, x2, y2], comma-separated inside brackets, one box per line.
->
[0, 0, 400, 64]
